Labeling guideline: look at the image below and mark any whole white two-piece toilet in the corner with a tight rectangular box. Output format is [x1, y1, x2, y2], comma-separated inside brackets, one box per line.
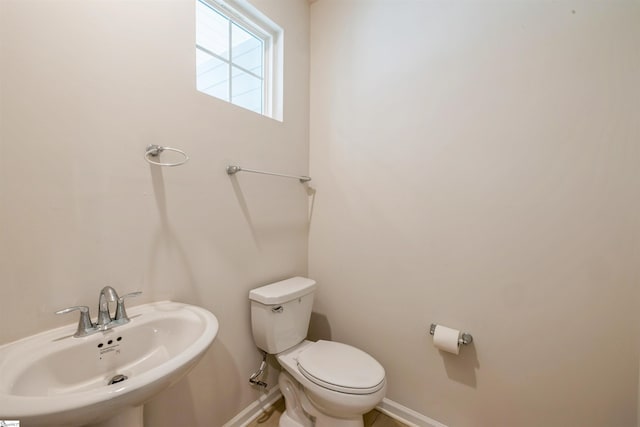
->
[249, 277, 387, 427]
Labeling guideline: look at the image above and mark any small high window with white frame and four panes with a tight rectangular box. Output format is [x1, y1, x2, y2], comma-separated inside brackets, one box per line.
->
[196, 0, 282, 120]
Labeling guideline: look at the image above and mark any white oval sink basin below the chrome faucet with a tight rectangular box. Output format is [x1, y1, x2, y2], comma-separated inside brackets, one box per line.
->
[0, 301, 218, 427]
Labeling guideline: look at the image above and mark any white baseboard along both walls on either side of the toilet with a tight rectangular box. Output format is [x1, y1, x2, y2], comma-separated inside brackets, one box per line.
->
[222, 386, 447, 427]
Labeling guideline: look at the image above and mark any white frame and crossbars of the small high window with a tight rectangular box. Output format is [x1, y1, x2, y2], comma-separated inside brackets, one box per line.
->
[195, 0, 284, 121]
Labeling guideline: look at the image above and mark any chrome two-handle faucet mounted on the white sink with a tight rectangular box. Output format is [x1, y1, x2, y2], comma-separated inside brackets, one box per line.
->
[56, 286, 142, 338]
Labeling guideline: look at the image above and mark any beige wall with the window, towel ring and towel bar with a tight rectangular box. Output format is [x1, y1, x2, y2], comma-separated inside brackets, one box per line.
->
[0, 0, 309, 427]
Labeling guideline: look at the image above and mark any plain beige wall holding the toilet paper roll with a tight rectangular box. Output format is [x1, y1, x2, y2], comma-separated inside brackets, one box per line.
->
[309, 0, 640, 427]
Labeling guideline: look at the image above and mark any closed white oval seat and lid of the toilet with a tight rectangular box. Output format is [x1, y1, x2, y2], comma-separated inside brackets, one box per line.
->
[297, 340, 385, 394]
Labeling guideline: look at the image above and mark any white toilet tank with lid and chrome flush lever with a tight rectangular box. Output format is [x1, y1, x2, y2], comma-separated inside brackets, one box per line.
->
[249, 277, 316, 354]
